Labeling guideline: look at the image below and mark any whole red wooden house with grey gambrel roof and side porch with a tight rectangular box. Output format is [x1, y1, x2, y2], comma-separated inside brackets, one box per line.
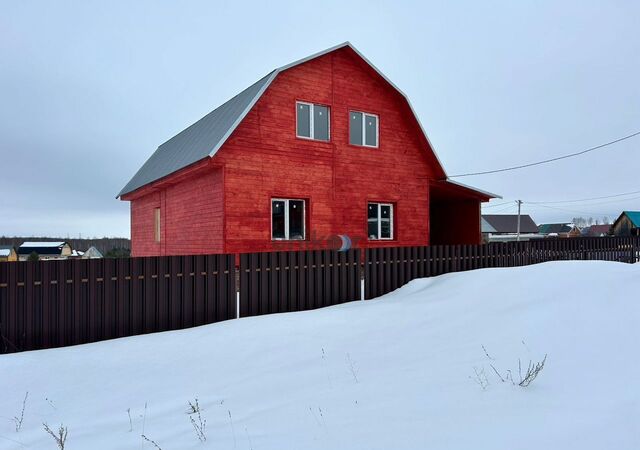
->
[119, 43, 495, 256]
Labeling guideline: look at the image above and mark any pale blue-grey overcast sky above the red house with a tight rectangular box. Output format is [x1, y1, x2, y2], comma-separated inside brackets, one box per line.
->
[0, 0, 640, 237]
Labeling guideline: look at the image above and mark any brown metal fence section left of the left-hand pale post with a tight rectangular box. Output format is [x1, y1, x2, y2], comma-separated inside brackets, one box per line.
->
[0, 255, 237, 353]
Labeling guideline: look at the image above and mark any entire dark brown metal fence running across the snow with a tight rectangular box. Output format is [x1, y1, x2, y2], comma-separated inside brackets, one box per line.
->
[0, 237, 640, 353]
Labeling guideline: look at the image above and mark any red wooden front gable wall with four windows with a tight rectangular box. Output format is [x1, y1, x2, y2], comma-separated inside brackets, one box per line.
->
[215, 50, 434, 252]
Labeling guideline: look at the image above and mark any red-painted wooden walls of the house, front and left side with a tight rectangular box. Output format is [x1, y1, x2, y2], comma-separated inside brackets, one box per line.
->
[130, 48, 479, 256]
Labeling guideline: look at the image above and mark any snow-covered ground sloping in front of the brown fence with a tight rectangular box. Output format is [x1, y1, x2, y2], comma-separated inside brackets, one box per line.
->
[0, 262, 640, 450]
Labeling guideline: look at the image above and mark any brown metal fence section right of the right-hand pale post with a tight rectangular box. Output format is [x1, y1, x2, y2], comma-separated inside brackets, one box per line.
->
[364, 237, 640, 299]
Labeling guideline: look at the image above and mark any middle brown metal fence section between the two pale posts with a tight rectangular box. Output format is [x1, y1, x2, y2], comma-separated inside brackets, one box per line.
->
[240, 249, 361, 317]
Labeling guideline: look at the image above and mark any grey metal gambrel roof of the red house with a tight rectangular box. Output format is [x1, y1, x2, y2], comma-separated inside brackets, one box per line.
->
[118, 42, 495, 197]
